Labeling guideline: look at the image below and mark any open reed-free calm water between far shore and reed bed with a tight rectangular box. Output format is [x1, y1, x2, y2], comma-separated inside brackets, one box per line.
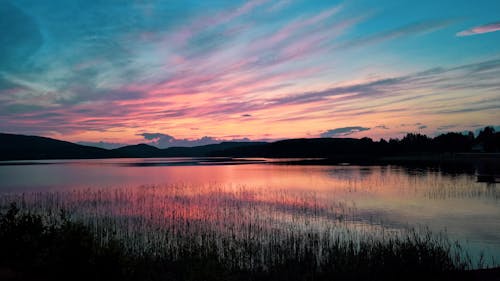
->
[0, 158, 500, 263]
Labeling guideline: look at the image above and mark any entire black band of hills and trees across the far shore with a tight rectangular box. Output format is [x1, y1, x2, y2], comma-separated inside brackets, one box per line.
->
[0, 127, 500, 162]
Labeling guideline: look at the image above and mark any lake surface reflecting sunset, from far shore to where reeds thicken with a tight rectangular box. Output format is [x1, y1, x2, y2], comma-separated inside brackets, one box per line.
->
[0, 158, 500, 263]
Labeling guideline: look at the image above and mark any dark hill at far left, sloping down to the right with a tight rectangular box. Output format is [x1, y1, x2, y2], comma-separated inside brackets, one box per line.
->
[0, 133, 114, 160]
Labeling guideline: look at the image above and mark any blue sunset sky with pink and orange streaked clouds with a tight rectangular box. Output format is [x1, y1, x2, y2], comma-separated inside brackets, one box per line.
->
[0, 0, 500, 148]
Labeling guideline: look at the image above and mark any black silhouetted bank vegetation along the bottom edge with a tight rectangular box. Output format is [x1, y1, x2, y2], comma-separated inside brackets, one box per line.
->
[0, 204, 500, 280]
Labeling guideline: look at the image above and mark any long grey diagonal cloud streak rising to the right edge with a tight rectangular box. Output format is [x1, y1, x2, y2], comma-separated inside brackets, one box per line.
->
[272, 60, 500, 109]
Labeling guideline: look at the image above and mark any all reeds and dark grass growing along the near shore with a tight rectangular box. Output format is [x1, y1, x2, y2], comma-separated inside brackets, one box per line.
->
[0, 185, 484, 280]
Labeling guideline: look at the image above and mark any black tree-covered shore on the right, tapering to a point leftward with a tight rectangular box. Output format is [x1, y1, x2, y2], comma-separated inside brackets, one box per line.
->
[216, 127, 500, 160]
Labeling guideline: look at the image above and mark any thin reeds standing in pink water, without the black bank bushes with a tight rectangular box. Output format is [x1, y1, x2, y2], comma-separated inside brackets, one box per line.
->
[0, 184, 471, 279]
